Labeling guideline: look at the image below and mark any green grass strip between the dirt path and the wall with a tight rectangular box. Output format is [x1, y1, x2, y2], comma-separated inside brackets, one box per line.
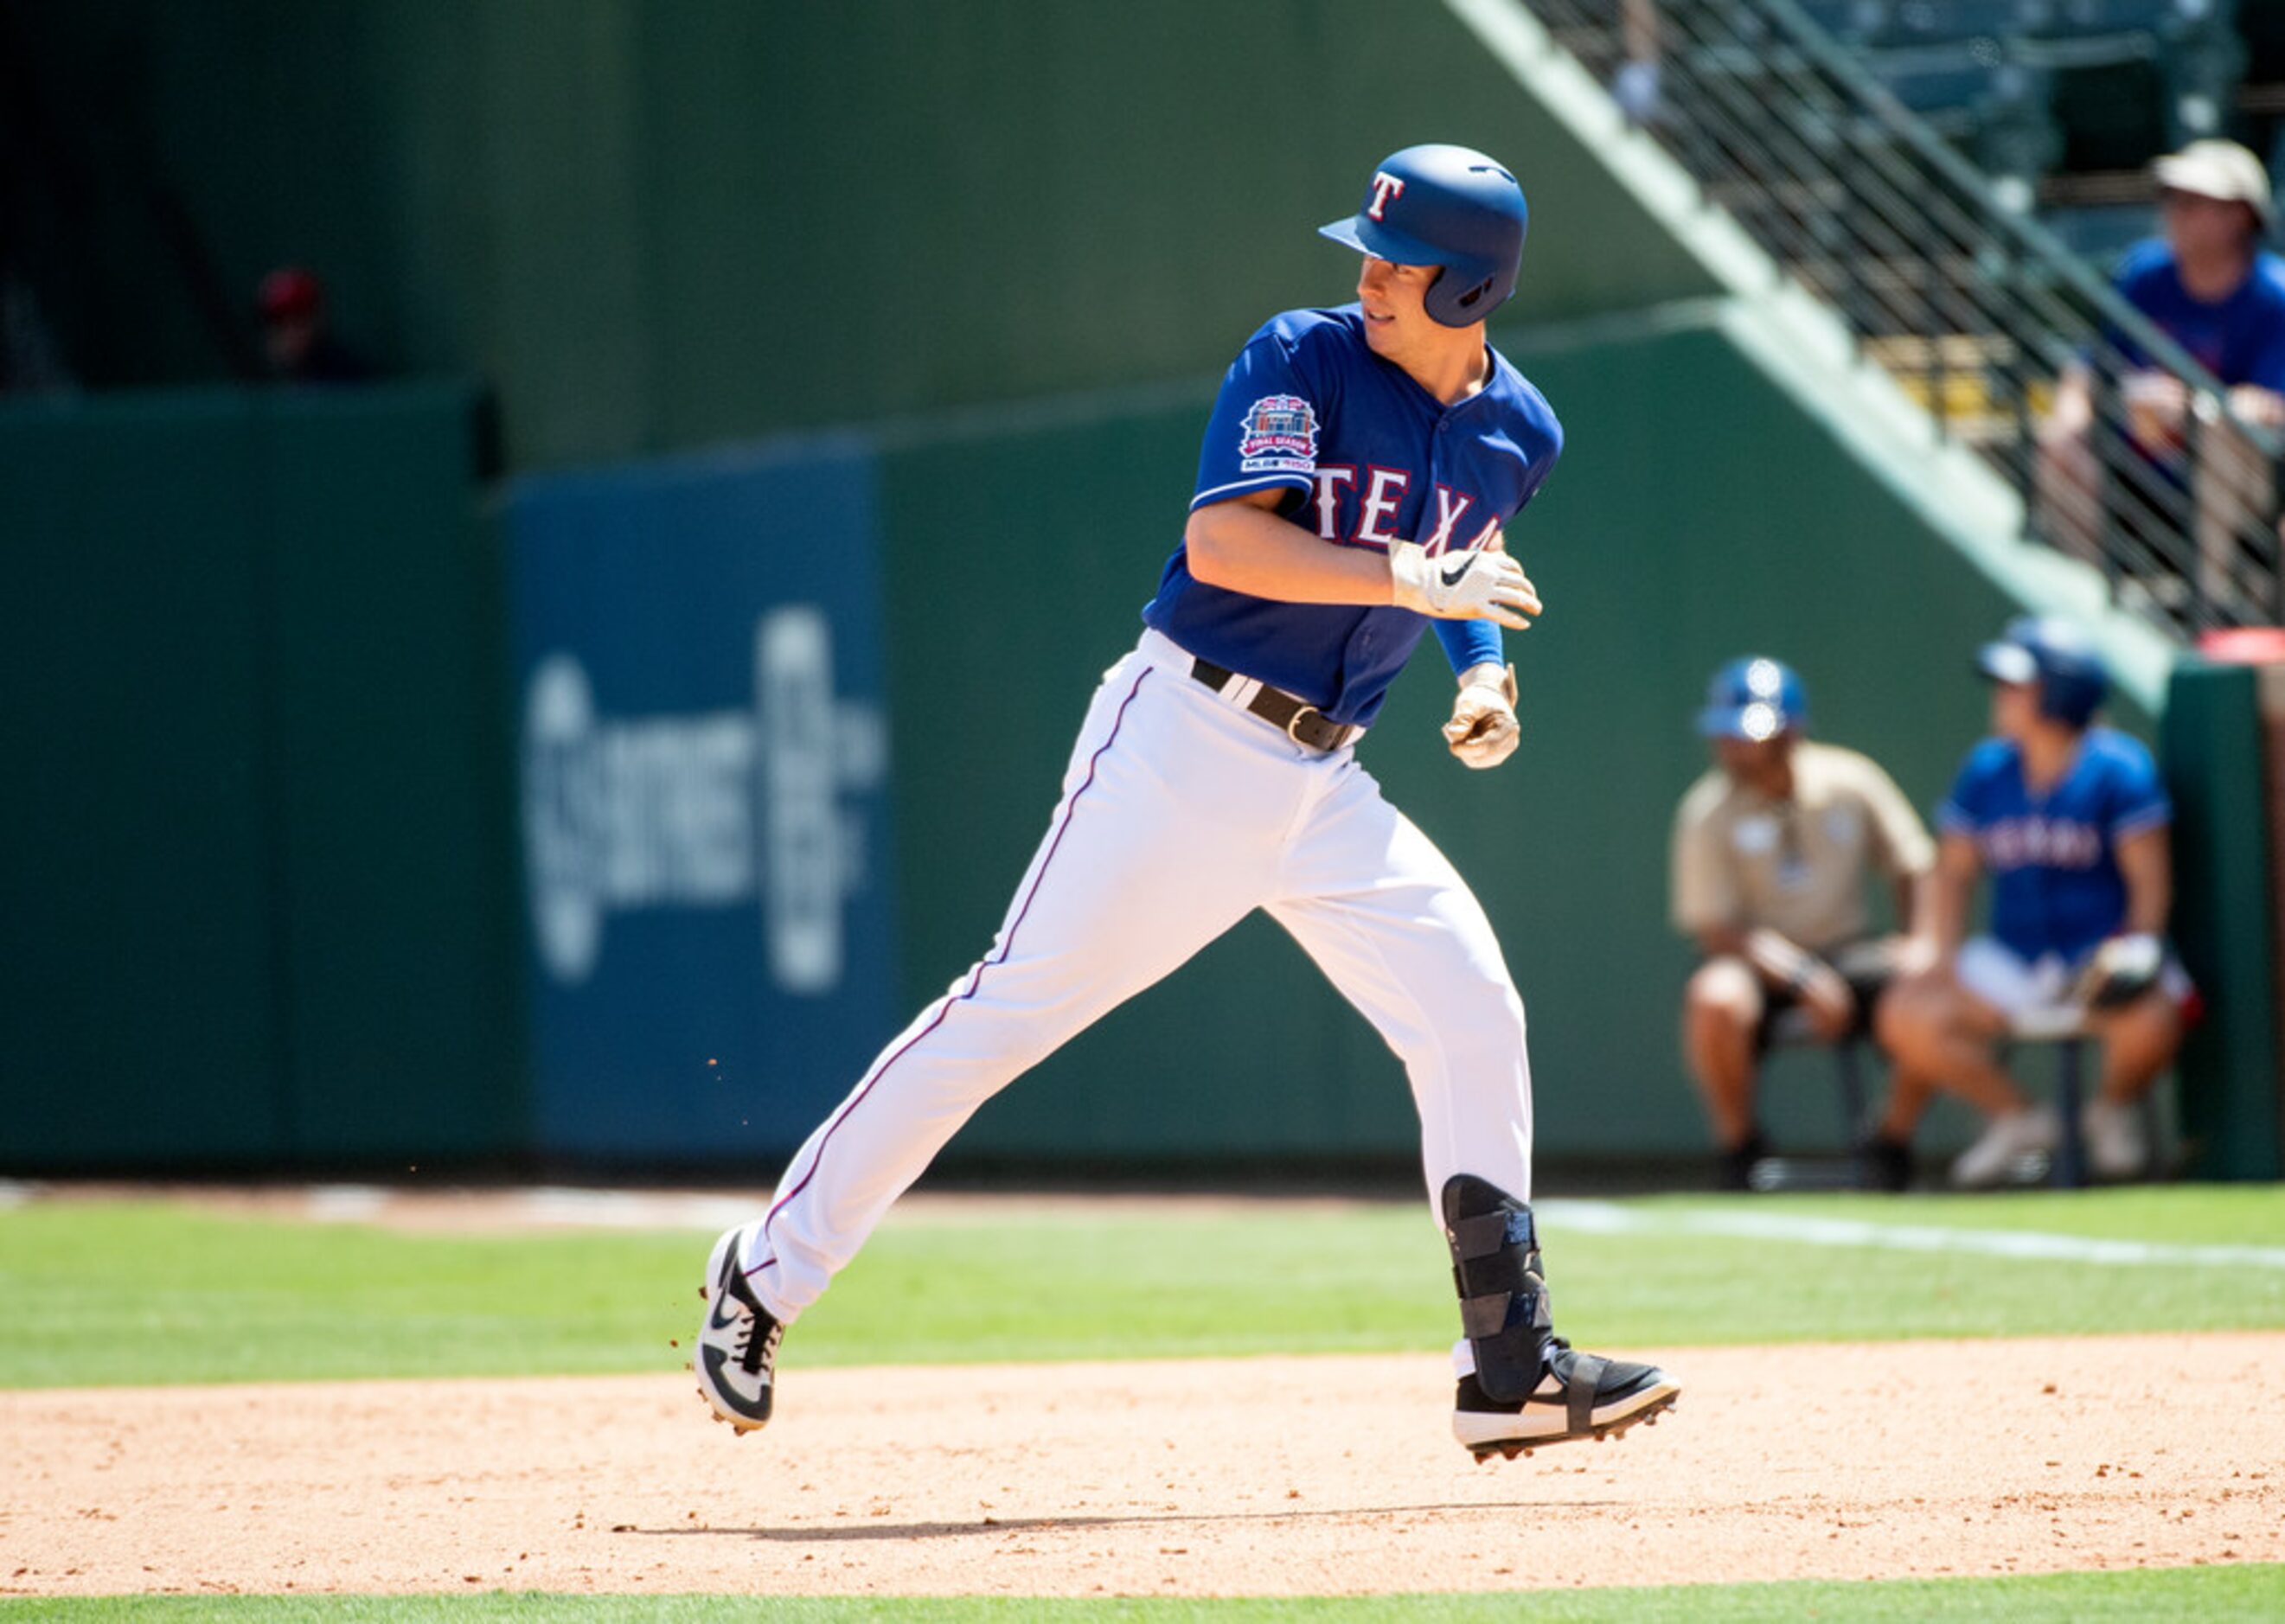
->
[0, 1186, 2285, 1386]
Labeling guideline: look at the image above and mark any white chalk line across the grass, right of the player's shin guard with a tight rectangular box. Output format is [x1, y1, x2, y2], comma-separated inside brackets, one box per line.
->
[1531, 1199, 2285, 1270]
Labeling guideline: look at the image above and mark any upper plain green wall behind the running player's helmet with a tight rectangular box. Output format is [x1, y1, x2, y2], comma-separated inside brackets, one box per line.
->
[0, 0, 1714, 468]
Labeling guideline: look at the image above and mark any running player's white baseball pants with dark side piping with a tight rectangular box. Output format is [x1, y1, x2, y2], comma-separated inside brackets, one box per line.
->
[745, 630, 1531, 1322]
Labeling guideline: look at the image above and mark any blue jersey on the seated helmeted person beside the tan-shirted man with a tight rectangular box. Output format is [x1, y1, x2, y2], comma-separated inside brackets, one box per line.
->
[1936, 726, 2173, 962]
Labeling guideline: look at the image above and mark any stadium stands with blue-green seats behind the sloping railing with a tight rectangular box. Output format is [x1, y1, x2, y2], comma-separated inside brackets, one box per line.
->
[1531, 0, 2285, 635]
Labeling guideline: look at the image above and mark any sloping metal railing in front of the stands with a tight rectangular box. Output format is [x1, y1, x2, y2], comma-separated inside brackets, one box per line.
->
[1527, 0, 2285, 637]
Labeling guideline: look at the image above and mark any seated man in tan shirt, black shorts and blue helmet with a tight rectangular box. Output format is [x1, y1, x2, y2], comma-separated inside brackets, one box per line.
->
[1673, 658, 1936, 1190]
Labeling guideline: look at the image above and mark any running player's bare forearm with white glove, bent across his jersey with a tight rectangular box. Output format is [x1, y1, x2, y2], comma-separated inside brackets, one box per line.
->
[1181, 489, 1540, 630]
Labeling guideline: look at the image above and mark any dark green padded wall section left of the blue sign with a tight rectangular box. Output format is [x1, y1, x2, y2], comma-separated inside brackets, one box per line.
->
[0, 386, 521, 1169]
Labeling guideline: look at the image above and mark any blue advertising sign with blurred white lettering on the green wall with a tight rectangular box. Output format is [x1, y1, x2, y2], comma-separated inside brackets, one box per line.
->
[509, 445, 898, 1162]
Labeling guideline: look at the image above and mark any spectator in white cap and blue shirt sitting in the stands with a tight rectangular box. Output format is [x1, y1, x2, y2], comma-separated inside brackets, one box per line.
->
[2039, 142, 2285, 621]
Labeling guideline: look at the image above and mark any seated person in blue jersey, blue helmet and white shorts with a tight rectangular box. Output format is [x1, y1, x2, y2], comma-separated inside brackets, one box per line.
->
[1880, 617, 2192, 1188]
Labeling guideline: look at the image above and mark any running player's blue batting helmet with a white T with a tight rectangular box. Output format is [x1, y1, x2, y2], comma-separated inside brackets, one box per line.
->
[1318, 144, 1531, 327]
